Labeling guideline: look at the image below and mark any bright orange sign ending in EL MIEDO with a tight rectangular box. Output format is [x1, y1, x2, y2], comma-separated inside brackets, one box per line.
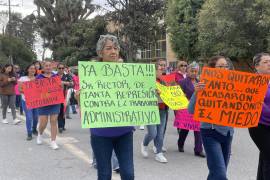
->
[194, 68, 270, 128]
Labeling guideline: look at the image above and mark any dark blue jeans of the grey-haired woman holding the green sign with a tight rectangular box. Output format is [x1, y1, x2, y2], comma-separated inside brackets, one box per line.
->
[91, 132, 134, 180]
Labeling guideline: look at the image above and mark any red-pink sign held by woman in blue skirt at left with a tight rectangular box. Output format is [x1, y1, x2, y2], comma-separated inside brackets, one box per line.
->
[22, 76, 64, 108]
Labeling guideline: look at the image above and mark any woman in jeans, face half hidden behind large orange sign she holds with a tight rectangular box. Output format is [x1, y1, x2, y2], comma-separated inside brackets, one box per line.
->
[188, 56, 234, 180]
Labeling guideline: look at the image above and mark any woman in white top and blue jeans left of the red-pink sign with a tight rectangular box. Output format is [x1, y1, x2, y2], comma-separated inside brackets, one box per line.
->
[18, 64, 38, 141]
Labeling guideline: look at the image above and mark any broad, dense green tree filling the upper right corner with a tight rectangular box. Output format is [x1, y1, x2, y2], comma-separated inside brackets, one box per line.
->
[198, 0, 270, 59]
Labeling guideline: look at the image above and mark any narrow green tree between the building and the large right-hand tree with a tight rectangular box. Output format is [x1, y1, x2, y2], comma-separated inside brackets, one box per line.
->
[166, 0, 204, 60]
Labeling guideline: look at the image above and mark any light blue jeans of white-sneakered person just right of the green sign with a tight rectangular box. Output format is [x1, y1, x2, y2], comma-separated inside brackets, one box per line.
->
[143, 110, 168, 153]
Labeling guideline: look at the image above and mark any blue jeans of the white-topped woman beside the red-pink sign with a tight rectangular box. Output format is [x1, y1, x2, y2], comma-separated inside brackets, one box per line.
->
[22, 100, 38, 135]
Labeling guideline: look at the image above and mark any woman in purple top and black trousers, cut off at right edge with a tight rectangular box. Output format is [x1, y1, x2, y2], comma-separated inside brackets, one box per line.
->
[249, 53, 270, 180]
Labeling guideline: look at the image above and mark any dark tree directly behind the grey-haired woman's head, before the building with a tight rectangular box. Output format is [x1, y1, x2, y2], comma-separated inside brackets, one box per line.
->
[107, 0, 165, 60]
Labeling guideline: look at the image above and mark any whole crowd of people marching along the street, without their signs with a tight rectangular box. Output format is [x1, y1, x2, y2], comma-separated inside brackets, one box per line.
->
[0, 35, 270, 180]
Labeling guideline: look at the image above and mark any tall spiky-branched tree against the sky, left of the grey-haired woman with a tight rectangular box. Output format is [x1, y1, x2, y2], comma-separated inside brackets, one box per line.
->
[34, 0, 98, 60]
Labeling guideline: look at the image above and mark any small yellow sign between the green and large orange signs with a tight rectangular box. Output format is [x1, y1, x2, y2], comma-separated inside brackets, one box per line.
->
[157, 83, 188, 110]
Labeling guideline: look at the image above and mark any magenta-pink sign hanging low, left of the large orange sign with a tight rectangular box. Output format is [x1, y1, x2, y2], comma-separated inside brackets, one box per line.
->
[173, 109, 200, 131]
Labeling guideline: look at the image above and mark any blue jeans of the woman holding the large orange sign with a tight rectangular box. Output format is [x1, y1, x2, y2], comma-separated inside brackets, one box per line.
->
[201, 129, 232, 180]
